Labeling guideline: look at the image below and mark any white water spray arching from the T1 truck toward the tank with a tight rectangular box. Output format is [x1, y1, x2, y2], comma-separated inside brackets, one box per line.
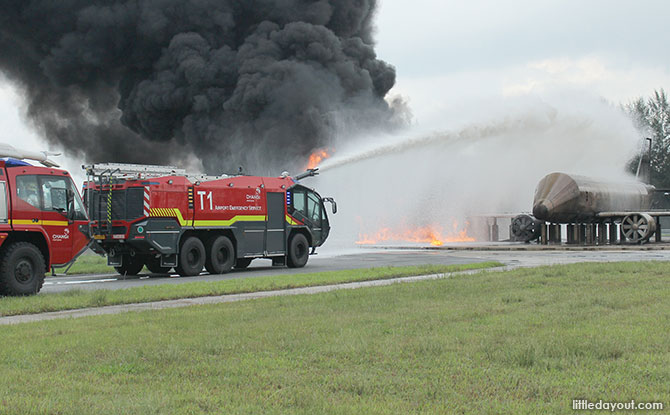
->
[316, 94, 639, 248]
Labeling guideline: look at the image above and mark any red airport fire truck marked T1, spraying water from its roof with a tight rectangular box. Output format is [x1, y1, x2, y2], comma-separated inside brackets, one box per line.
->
[82, 163, 337, 276]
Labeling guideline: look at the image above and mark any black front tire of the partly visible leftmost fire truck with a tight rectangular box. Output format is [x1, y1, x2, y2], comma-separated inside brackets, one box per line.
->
[0, 242, 46, 296]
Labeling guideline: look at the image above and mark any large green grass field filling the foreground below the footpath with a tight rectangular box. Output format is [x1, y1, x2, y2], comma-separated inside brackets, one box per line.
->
[0, 263, 670, 415]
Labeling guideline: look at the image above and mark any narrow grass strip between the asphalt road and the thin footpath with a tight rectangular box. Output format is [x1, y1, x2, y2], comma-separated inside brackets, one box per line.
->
[0, 262, 502, 316]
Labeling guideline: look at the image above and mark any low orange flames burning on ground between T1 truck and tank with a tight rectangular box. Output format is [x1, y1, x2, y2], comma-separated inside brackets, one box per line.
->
[356, 221, 475, 246]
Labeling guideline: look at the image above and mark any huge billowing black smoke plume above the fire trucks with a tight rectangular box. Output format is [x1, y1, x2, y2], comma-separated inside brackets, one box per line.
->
[0, 0, 396, 172]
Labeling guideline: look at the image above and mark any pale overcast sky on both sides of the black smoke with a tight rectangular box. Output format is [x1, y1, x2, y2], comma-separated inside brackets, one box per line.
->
[0, 0, 670, 173]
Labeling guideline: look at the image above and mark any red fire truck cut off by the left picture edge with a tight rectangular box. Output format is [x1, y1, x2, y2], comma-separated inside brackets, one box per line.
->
[0, 144, 89, 295]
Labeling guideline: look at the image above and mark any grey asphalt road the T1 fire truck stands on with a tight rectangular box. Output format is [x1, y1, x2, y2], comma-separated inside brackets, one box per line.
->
[42, 247, 670, 293]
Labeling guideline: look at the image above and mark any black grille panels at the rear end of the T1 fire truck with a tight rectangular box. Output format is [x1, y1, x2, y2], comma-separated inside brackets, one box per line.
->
[86, 187, 144, 221]
